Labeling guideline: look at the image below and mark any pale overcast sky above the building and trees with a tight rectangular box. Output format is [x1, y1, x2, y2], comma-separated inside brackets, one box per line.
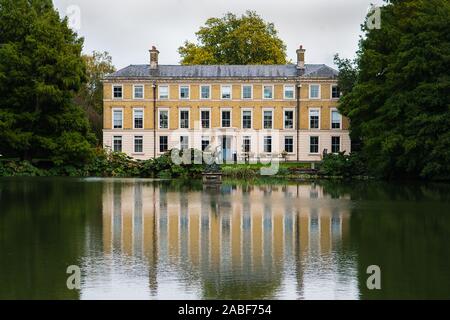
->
[53, 0, 382, 69]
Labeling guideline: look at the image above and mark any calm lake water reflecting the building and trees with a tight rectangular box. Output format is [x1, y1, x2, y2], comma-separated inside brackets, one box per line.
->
[0, 178, 450, 300]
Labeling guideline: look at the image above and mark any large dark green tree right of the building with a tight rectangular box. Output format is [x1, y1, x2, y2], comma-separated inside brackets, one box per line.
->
[337, 0, 450, 179]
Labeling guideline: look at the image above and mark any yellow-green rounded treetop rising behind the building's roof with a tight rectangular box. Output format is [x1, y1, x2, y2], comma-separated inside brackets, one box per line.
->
[178, 11, 286, 65]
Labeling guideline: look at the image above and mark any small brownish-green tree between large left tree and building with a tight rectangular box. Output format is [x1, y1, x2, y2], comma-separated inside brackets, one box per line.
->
[75, 51, 116, 143]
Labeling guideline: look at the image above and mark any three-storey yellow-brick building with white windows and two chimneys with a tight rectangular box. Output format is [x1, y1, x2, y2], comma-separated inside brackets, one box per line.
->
[104, 47, 351, 161]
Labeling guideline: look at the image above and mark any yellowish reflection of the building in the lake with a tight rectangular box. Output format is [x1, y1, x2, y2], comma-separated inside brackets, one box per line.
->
[103, 183, 356, 299]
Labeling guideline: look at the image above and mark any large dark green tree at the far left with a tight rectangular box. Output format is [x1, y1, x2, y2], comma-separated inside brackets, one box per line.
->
[0, 0, 95, 163]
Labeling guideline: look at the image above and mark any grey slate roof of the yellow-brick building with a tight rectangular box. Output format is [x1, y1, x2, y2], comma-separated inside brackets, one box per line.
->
[105, 64, 338, 79]
